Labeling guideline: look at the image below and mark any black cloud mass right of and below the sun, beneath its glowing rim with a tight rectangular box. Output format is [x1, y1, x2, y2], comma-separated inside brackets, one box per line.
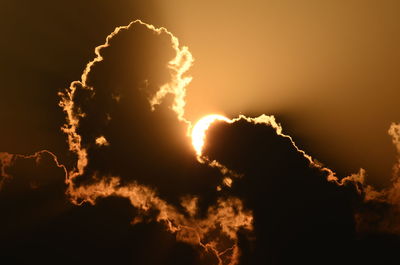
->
[204, 119, 400, 264]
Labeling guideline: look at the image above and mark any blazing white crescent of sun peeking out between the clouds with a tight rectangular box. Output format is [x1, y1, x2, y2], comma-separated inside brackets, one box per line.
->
[192, 114, 231, 156]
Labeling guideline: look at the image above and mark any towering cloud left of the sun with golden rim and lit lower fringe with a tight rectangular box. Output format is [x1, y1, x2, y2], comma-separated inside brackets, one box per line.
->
[56, 20, 252, 264]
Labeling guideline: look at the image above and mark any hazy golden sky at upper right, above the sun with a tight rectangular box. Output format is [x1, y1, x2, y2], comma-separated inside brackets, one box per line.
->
[156, 0, 400, 186]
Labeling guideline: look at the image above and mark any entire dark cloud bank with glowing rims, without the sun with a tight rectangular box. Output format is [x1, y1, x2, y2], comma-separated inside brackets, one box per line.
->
[0, 3, 400, 265]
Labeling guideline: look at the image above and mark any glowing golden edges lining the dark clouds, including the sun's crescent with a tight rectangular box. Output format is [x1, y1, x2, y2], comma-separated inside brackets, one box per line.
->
[0, 20, 400, 264]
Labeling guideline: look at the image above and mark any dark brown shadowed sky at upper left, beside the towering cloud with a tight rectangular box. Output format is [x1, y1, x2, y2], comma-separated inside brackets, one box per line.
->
[0, 0, 161, 159]
